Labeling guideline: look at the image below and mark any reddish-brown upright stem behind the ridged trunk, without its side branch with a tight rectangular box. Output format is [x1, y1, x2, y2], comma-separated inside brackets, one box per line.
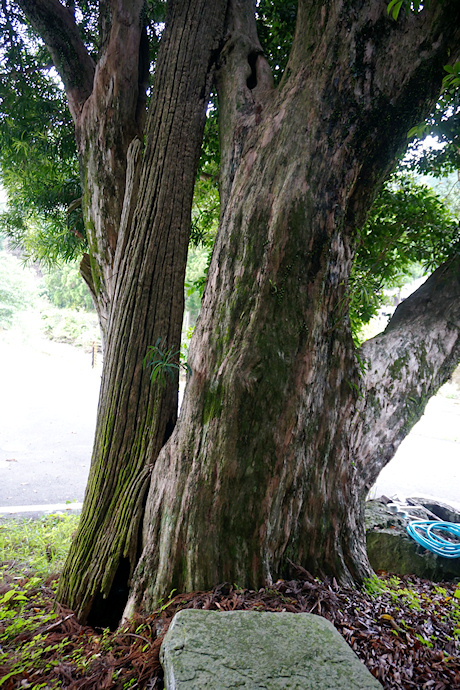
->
[76, 0, 145, 335]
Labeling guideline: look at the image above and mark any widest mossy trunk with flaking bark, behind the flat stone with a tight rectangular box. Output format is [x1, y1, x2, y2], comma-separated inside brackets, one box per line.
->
[127, 0, 460, 613]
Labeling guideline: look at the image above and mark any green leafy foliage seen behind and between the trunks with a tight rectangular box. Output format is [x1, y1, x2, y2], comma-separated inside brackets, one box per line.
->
[0, 0, 460, 338]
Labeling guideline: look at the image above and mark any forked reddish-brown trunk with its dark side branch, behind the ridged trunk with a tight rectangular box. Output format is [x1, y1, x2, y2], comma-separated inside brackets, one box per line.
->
[19, 0, 148, 341]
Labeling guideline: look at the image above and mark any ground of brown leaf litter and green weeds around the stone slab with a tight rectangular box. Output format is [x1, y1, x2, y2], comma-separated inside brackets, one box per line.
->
[0, 568, 460, 690]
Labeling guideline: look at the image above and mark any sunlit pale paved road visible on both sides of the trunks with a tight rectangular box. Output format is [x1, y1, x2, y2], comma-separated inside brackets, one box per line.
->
[0, 336, 460, 516]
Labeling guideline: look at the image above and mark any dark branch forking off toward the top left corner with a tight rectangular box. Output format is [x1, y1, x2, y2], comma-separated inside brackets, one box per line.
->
[18, 0, 95, 120]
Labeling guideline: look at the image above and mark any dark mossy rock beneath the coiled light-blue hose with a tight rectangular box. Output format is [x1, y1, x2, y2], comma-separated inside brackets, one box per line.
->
[365, 501, 460, 582]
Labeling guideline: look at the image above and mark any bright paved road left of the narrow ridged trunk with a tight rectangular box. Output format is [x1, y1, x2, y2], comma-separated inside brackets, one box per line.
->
[0, 339, 101, 507]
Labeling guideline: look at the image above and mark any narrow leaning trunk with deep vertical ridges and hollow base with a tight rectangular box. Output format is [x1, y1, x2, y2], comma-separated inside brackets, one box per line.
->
[58, 0, 226, 624]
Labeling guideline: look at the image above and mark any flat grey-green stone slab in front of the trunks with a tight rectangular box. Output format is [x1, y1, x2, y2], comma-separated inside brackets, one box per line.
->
[160, 609, 382, 690]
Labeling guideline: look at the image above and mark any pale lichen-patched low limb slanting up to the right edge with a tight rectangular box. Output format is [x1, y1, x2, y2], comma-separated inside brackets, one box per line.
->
[352, 255, 460, 489]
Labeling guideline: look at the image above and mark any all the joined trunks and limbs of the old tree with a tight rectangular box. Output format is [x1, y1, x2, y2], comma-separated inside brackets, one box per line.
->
[19, 0, 460, 625]
